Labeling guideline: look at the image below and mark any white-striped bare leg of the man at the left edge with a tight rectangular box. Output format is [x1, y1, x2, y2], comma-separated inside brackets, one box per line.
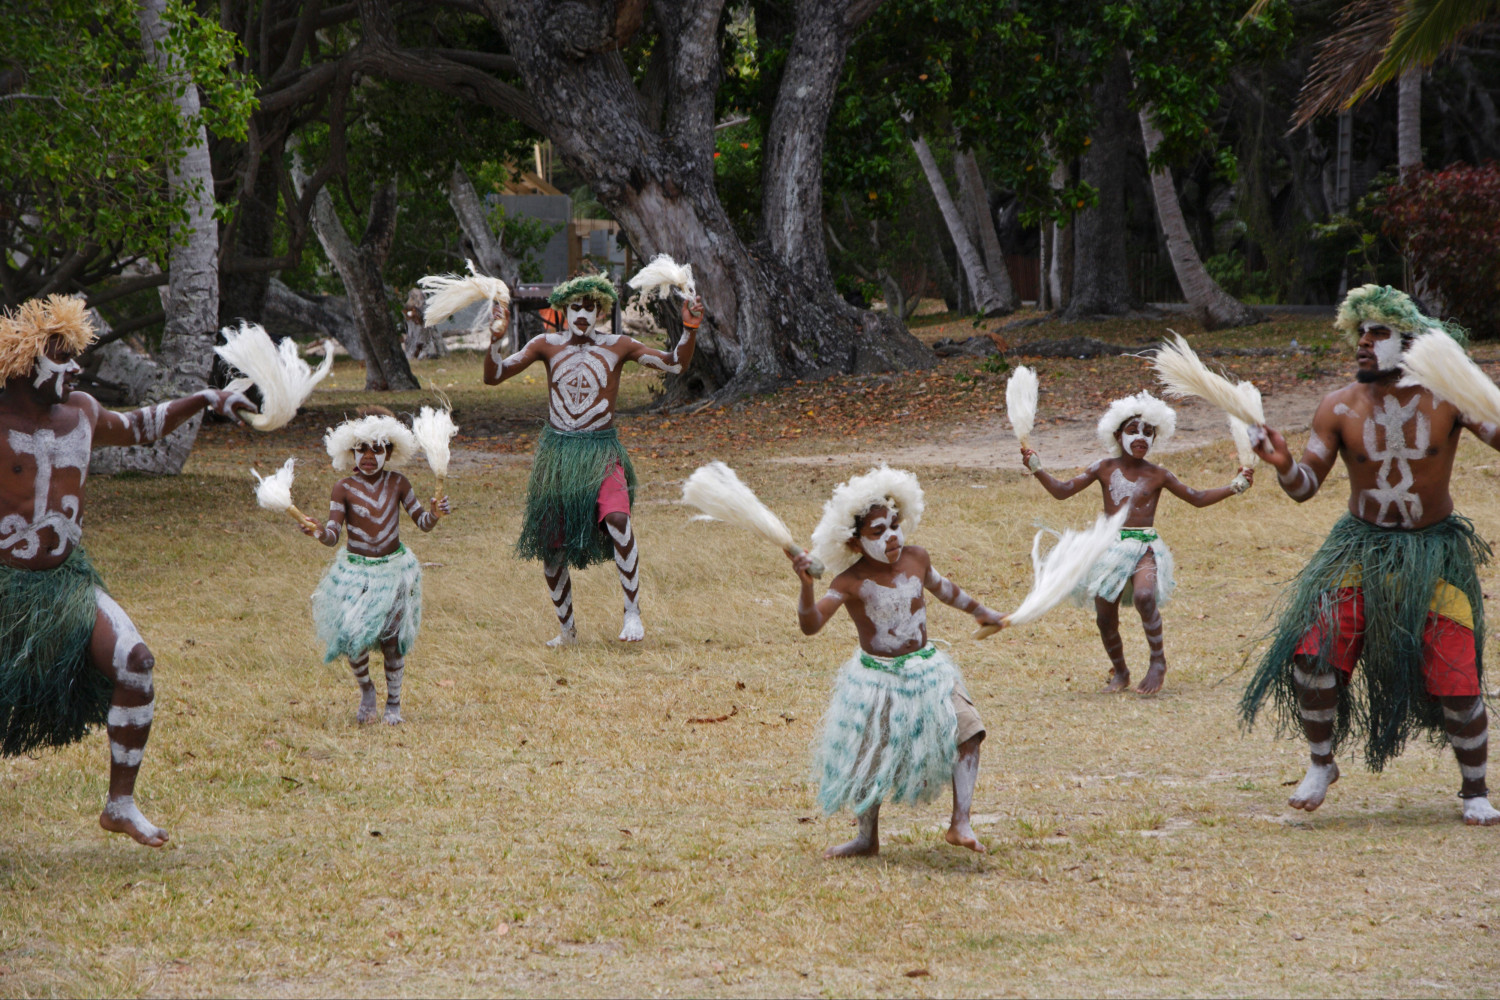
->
[89, 588, 168, 847]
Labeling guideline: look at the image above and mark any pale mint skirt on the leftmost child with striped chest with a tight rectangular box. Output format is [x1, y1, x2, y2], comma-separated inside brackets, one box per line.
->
[312, 546, 422, 663]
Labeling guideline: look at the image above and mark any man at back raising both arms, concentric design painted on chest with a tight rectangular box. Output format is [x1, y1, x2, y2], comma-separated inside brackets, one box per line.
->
[485, 274, 704, 648]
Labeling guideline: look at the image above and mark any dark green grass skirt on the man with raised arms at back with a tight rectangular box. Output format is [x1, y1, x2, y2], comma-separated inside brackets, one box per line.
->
[516, 424, 636, 570]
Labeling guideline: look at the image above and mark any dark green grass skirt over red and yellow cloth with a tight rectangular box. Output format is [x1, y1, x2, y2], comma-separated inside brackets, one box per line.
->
[1239, 514, 1490, 771]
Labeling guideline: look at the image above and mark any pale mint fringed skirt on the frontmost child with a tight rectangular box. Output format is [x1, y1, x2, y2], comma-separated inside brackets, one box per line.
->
[815, 643, 959, 816]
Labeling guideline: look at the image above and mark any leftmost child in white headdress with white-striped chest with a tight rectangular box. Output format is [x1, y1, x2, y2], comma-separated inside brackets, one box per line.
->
[302, 406, 450, 726]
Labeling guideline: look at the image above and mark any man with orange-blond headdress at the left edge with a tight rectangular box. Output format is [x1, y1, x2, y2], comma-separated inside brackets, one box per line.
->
[0, 295, 255, 847]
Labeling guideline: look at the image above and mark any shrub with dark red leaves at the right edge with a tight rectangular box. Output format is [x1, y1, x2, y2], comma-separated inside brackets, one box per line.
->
[1376, 160, 1500, 339]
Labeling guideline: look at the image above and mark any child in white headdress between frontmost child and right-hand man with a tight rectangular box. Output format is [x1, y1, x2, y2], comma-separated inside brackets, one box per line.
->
[1022, 393, 1254, 694]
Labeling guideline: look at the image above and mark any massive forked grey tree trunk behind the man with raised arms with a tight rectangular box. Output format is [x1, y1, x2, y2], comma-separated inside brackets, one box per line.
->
[486, 0, 933, 402]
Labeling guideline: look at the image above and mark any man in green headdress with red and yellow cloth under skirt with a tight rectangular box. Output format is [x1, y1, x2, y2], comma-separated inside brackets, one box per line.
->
[1241, 285, 1500, 826]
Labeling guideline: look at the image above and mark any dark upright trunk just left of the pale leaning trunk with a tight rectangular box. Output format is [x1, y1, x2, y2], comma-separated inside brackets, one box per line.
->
[1062, 52, 1136, 319]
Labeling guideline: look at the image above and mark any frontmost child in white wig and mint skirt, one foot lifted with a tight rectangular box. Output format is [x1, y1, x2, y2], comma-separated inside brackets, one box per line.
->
[788, 466, 1005, 858]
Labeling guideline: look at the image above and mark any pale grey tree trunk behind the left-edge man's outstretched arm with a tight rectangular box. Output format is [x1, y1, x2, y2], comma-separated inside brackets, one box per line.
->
[90, 0, 219, 475]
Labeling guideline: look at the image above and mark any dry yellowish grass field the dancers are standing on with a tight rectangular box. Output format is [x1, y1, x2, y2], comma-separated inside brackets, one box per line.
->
[0, 325, 1500, 996]
